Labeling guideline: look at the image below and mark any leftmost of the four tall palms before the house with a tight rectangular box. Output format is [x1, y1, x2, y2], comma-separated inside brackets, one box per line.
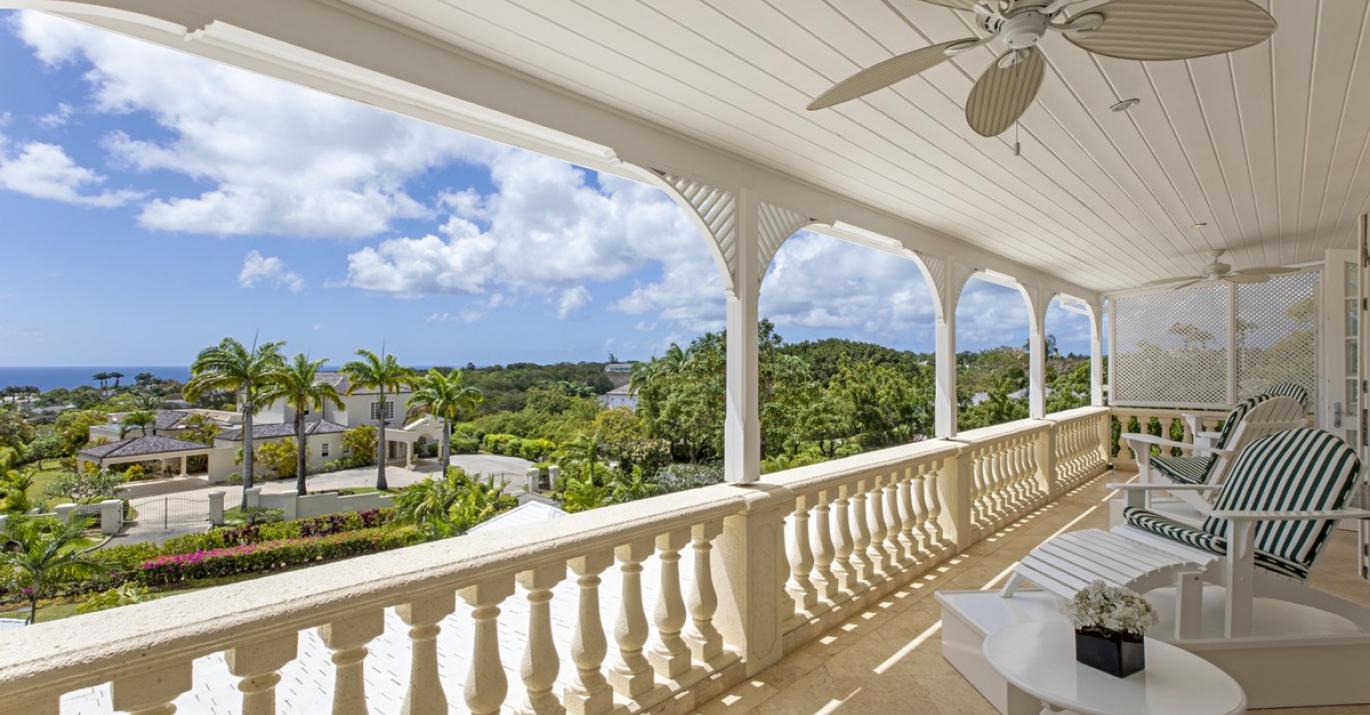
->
[182, 337, 285, 508]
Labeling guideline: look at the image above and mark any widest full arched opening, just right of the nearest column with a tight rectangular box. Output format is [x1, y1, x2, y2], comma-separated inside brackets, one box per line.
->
[760, 230, 936, 473]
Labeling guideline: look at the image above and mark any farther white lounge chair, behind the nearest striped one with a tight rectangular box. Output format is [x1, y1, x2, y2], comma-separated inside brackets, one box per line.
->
[1122, 394, 1304, 514]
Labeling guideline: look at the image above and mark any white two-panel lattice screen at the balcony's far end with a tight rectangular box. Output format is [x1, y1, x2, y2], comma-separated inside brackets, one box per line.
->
[1108, 271, 1318, 408]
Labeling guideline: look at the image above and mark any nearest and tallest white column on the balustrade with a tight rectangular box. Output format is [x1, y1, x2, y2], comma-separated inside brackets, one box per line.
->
[723, 189, 762, 482]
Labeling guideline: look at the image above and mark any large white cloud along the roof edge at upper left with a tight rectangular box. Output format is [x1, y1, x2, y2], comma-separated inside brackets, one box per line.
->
[16, 12, 492, 238]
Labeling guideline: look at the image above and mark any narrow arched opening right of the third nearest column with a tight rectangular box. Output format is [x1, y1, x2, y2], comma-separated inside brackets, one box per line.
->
[1043, 294, 1093, 414]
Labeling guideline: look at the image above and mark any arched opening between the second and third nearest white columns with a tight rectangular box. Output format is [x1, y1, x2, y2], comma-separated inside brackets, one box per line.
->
[956, 274, 1032, 430]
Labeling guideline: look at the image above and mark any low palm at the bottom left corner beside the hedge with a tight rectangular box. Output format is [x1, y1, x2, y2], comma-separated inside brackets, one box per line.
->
[0, 514, 104, 623]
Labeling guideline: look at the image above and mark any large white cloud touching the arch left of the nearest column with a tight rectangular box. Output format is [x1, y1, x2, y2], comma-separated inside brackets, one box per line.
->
[348, 149, 722, 329]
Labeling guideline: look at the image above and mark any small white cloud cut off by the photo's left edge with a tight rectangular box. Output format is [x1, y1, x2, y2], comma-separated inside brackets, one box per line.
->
[0, 137, 141, 208]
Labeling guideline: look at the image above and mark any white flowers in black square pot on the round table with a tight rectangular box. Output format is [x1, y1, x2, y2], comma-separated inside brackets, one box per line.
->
[1069, 581, 1158, 678]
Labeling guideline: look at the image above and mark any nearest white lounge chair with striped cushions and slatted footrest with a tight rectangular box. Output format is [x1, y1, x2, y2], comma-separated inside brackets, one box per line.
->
[1001, 429, 1370, 640]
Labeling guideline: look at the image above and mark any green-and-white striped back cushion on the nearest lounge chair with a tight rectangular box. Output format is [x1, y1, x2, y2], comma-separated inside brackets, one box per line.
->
[1203, 427, 1360, 573]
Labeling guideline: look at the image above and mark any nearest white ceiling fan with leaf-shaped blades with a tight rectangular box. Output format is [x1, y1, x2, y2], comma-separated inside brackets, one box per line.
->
[808, 0, 1275, 137]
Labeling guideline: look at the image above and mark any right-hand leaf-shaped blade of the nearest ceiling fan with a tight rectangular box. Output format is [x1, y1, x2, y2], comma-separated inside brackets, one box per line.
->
[1064, 0, 1275, 60]
